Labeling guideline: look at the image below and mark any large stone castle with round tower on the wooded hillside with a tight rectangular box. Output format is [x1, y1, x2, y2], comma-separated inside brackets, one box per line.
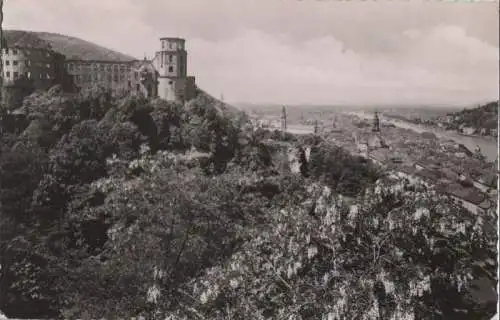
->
[2, 32, 196, 107]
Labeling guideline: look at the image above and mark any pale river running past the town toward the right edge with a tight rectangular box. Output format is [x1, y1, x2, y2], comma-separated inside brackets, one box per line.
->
[348, 112, 499, 161]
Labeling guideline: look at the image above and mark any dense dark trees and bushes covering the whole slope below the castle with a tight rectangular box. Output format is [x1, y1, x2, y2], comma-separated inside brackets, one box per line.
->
[0, 88, 496, 319]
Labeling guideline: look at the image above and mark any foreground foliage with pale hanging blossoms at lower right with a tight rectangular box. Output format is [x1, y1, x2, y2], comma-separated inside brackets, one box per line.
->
[167, 181, 496, 319]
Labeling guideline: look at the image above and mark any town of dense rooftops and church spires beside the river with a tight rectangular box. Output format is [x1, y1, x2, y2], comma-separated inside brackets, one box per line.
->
[248, 108, 498, 214]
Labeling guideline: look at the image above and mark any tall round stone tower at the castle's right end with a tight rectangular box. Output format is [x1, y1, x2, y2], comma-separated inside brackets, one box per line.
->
[154, 37, 194, 101]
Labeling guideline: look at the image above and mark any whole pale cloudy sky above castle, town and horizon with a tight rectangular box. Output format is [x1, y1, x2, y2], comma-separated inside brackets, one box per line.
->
[4, 0, 499, 106]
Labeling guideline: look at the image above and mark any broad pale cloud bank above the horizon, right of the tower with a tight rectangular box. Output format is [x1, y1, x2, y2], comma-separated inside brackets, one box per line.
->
[188, 26, 498, 104]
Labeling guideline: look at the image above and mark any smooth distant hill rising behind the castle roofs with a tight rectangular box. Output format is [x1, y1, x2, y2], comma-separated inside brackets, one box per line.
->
[4, 30, 137, 61]
